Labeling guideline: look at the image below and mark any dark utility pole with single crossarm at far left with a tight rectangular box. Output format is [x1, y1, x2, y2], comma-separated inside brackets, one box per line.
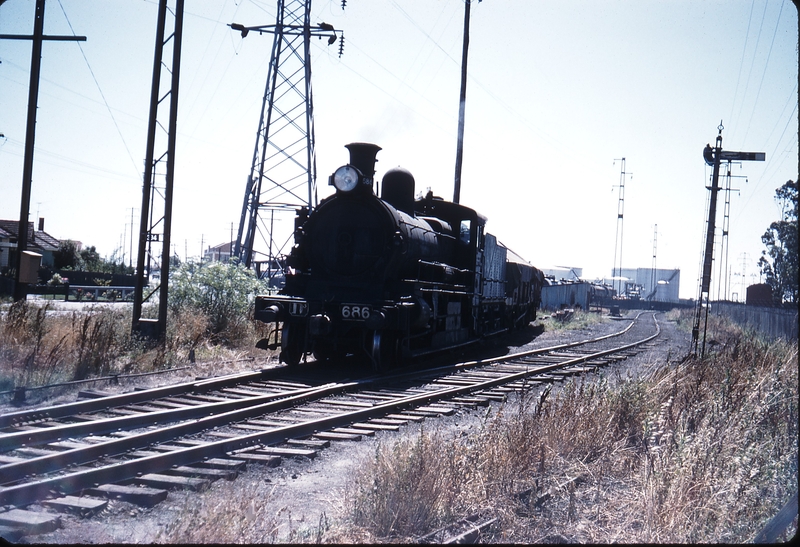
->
[0, 0, 86, 302]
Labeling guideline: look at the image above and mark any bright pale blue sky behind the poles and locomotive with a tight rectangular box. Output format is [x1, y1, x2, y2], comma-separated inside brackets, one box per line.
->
[0, 0, 798, 298]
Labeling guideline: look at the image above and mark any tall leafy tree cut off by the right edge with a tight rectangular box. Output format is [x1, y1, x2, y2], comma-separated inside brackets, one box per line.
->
[758, 180, 798, 304]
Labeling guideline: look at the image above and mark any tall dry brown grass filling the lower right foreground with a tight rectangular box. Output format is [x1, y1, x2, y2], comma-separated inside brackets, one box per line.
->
[340, 314, 798, 543]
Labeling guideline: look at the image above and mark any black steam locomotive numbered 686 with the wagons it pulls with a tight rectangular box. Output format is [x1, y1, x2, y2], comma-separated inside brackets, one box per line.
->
[255, 143, 544, 371]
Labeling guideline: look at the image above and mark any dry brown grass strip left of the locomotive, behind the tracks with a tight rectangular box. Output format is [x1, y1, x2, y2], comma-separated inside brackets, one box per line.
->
[0, 301, 276, 398]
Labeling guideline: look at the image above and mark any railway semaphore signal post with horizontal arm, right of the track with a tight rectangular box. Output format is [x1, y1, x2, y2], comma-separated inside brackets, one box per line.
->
[692, 120, 766, 358]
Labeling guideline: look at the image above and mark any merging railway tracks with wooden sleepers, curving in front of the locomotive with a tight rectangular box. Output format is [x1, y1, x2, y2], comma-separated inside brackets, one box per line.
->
[0, 312, 660, 537]
